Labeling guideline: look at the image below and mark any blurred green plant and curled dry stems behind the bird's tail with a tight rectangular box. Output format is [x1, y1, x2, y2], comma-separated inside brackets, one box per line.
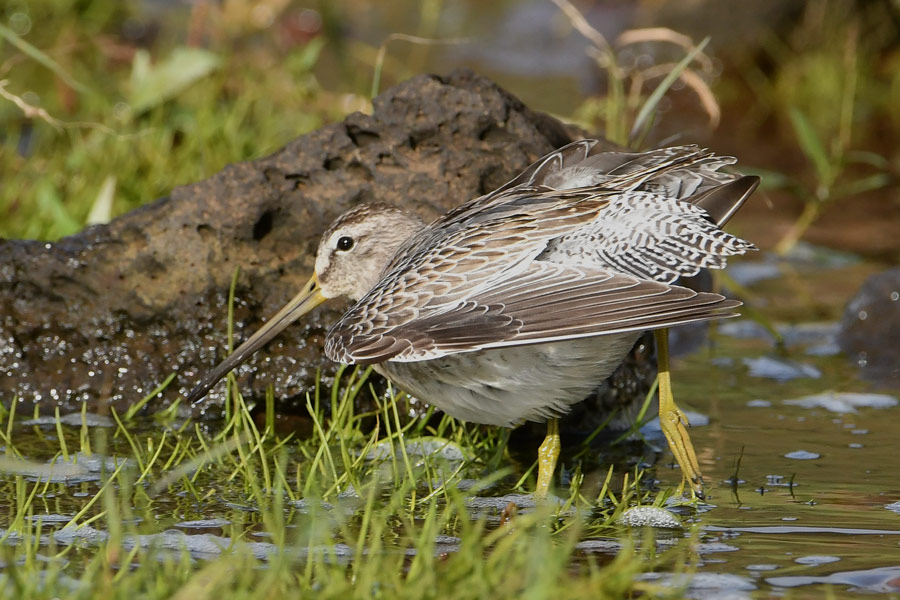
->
[553, 0, 900, 254]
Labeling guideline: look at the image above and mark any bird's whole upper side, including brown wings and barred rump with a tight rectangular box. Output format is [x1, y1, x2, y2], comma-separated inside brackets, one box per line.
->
[326, 140, 755, 363]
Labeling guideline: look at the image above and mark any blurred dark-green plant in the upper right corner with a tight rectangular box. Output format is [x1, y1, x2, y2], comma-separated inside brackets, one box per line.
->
[730, 0, 900, 256]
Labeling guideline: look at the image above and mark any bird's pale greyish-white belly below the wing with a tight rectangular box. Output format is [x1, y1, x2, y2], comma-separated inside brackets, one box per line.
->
[375, 332, 641, 427]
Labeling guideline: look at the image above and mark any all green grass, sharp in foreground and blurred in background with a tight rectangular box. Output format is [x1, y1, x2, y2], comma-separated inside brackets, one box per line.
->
[0, 0, 900, 600]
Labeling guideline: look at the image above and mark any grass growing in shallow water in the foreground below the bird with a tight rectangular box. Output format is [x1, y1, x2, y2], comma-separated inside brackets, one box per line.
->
[0, 369, 687, 598]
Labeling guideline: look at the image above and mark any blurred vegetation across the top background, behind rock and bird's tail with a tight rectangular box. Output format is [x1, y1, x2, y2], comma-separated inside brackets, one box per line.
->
[0, 0, 900, 252]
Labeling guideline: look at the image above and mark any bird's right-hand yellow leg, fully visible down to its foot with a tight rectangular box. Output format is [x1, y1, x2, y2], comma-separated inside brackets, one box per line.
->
[653, 329, 703, 497]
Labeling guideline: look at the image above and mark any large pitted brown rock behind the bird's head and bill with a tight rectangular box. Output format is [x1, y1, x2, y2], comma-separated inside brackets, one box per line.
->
[0, 72, 592, 411]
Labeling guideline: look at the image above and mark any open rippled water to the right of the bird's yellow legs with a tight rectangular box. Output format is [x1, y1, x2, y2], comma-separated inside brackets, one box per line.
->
[644, 330, 900, 597]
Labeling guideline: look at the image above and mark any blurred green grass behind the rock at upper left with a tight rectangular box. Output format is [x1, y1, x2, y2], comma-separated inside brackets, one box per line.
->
[0, 0, 342, 239]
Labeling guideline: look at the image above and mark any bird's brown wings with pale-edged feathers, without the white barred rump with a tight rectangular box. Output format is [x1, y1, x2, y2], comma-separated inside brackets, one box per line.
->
[326, 140, 752, 362]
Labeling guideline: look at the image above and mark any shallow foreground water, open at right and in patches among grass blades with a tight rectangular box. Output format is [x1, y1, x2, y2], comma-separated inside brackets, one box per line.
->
[0, 262, 900, 598]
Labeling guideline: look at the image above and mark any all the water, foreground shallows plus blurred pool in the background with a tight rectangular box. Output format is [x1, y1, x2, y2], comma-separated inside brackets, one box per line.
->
[0, 3, 900, 598]
